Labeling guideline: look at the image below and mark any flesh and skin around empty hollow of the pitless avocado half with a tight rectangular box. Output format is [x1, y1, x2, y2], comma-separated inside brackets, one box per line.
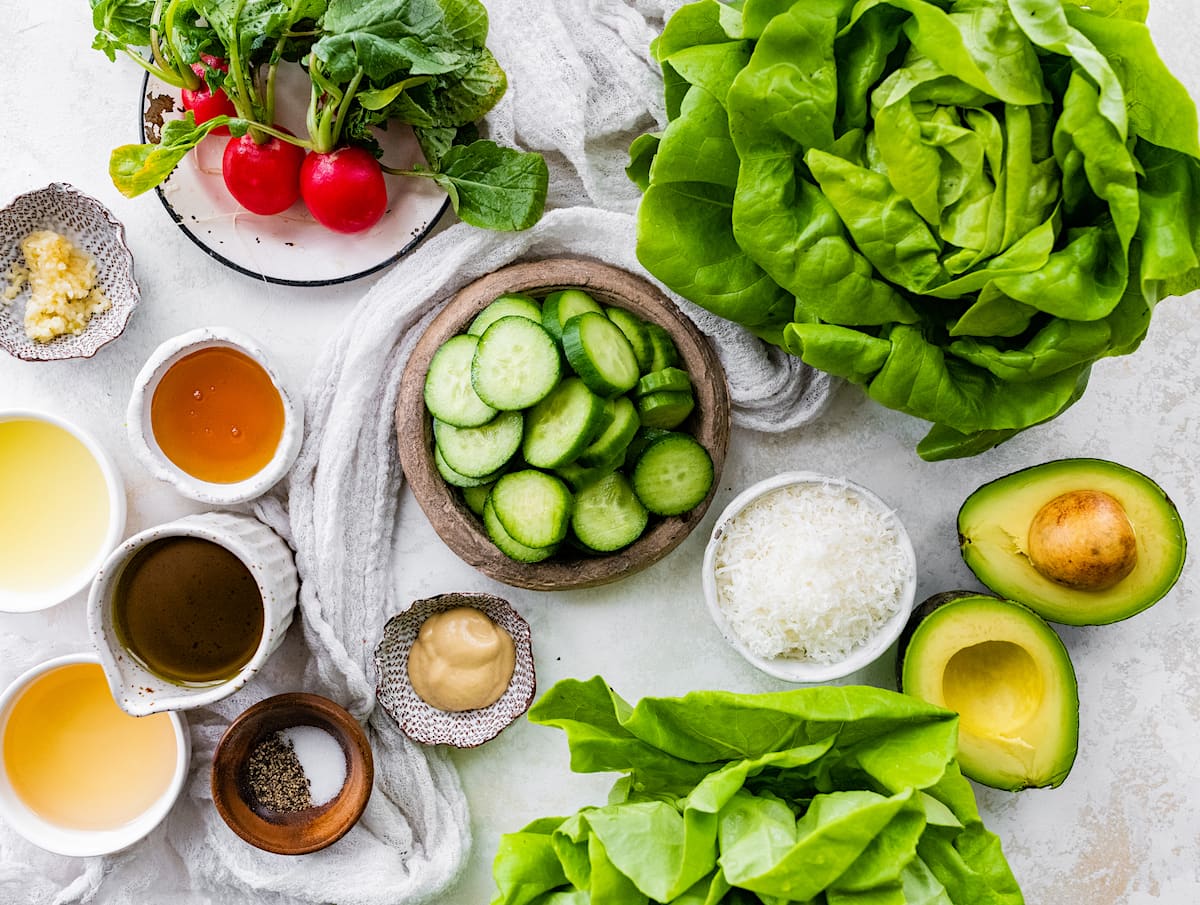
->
[896, 591, 1079, 792]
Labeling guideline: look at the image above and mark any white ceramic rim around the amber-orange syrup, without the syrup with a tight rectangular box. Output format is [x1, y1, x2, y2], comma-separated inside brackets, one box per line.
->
[125, 326, 304, 505]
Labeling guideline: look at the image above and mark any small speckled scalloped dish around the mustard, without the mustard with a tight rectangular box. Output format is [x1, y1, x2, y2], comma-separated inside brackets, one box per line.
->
[374, 593, 538, 748]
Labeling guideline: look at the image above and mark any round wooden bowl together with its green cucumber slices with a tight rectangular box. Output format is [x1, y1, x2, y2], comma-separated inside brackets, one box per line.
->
[396, 258, 730, 591]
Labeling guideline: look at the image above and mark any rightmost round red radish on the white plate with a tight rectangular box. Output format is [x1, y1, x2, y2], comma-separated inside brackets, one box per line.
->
[300, 145, 388, 233]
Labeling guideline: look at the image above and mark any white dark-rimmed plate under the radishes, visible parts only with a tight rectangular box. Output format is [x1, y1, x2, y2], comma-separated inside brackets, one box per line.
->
[138, 65, 449, 286]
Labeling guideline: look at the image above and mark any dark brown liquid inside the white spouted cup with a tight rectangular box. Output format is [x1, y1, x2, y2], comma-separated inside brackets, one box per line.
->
[113, 537, 264, 685]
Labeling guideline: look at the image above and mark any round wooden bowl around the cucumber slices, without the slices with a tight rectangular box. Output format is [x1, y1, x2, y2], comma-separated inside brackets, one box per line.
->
[396, 258, 730, 591]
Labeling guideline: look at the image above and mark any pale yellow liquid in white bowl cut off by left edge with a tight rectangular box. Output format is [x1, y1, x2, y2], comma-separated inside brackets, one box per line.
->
[0, 418, 110, 593]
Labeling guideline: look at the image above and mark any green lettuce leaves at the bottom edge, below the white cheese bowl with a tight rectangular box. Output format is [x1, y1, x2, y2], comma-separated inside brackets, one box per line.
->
[493, 677, 1024, 905]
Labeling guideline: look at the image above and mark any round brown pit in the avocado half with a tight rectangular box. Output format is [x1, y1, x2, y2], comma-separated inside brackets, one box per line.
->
[1028, 490, 1138, 591]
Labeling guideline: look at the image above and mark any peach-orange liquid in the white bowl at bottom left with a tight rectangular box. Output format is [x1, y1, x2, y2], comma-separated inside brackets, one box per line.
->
[4, 663, 179, 831]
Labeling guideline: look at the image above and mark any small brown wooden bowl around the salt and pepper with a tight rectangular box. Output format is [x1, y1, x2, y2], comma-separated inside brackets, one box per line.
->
[212, 693, 374, 855]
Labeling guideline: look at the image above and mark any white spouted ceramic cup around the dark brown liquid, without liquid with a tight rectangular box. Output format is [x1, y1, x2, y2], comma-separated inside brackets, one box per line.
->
[88, 513, 300, 717]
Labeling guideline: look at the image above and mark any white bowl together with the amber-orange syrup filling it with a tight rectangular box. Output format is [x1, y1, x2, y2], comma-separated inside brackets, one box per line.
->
[127, 326, 304, 505]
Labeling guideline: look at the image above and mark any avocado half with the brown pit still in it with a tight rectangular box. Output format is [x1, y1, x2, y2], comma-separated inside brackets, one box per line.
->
[959, 459, 1187, 625]
